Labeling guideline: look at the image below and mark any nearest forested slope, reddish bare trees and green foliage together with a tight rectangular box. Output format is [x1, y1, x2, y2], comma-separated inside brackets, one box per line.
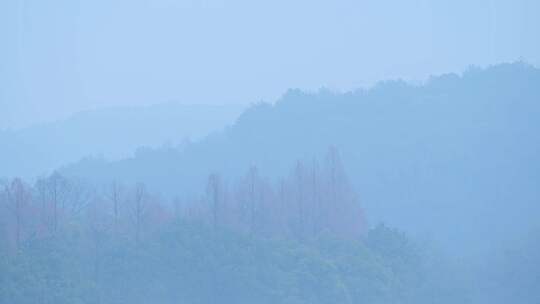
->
[0, 160, 472, 304]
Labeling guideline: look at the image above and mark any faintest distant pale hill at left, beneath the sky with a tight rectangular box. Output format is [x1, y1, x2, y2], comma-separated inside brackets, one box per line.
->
[0, 103, 244, 177]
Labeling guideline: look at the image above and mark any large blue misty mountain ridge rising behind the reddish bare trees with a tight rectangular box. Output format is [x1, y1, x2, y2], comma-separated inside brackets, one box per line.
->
[62, 63, 540, 253]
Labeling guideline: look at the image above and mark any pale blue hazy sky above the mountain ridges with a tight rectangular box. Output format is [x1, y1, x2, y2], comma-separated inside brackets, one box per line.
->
[0, 0, 540, 128]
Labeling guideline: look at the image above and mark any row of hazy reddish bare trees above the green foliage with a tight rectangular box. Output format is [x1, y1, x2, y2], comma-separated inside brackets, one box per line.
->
[0, 148, 366, 253]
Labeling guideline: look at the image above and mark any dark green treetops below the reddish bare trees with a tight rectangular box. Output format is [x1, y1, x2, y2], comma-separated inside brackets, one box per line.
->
[0, 222, 468, 304]
